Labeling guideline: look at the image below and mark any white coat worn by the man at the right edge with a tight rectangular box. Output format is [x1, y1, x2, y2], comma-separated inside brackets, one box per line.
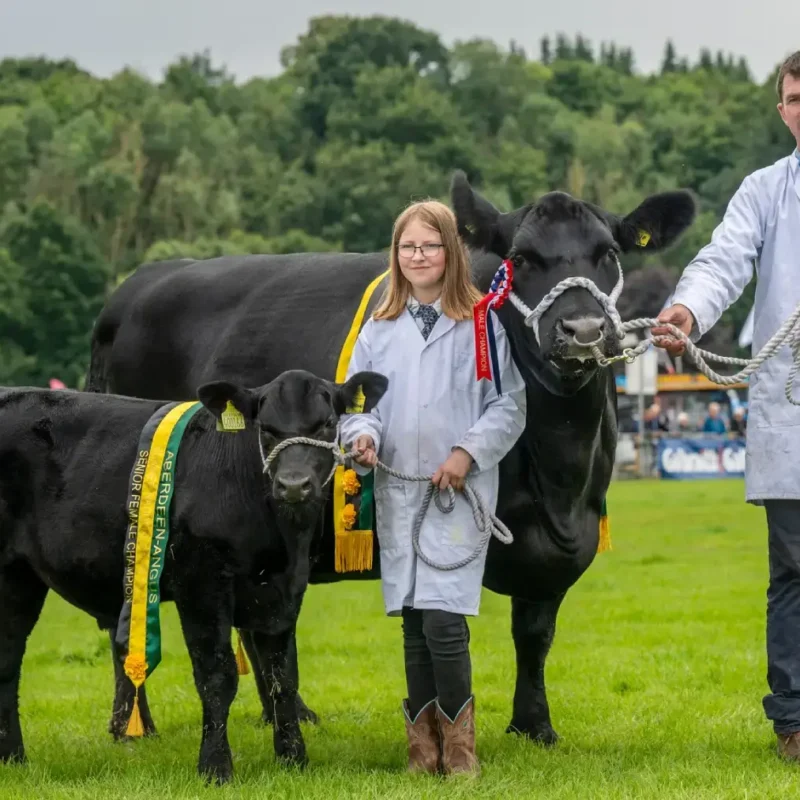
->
[673, 151, 800, 505]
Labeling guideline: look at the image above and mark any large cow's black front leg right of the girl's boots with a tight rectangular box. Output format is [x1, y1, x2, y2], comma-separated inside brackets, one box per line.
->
[507, 594, 564, 745]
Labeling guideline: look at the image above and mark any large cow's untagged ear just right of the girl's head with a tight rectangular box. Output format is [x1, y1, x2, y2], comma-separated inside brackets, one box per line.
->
[450, 170, 530, 258]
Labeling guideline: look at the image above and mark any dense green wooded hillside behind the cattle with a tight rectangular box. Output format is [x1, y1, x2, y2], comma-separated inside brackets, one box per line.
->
[0, 16, 791, 386]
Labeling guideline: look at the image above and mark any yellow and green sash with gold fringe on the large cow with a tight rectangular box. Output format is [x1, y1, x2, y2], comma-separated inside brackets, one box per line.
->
[333, 270, 389, 572]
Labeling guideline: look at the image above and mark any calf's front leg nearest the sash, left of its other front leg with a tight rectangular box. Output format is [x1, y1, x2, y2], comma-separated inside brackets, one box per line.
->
[175, 570, 239, 783]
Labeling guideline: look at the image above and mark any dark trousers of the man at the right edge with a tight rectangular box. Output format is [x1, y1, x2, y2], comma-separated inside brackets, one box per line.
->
[763, 500, 800, 733]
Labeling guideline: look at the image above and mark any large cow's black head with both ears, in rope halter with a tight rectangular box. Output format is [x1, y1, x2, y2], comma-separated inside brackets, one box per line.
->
[451, 171, 695, 393]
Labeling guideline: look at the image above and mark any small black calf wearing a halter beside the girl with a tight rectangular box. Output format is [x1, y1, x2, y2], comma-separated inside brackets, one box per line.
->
[0, 371, 388, 781]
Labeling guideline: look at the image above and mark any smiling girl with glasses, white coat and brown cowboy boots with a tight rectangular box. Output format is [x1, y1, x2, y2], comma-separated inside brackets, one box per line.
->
[342, 201, 526, 773]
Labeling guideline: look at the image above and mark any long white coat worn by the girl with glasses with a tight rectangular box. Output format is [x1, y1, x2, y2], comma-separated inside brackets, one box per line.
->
[342, 309, 526, 616]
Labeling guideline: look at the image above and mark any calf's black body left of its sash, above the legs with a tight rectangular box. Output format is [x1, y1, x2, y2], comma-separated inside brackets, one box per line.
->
[0, 389, 167, 618]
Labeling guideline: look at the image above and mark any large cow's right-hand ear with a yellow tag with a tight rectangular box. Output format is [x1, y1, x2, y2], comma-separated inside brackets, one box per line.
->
[612, 190, 697, 253]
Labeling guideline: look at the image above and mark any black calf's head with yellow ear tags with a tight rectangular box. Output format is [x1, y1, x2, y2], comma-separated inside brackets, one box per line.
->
[198, 370, 389, 514]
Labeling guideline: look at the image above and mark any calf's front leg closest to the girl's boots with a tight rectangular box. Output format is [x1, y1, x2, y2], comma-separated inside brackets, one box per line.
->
[257, 627, 308, 767]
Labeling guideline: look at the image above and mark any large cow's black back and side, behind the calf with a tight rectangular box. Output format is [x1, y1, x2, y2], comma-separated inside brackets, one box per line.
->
[94, 253, 388, 400]
